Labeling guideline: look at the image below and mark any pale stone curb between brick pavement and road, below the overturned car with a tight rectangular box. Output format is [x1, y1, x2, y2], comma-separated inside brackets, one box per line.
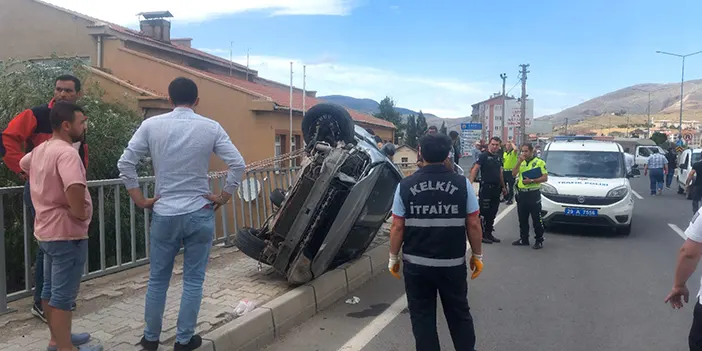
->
[203, 242, 389, 351]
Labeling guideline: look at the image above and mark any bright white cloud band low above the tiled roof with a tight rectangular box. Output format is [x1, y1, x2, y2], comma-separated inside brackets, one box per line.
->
[209, 49, 496, 117]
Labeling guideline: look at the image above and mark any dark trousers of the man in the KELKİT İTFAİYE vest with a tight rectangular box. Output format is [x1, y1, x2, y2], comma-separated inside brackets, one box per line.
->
[403, 262, 475, 351]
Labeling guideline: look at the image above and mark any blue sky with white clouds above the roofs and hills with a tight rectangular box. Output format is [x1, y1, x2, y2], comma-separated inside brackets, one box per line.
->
[48, 0, 702, 118]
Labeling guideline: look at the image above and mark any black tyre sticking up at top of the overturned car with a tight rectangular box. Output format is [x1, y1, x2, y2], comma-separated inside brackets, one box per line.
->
[302, 103, 355, 146]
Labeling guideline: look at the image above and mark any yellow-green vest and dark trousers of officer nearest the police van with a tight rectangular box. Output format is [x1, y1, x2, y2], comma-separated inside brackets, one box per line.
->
[513, 157, 548, 249]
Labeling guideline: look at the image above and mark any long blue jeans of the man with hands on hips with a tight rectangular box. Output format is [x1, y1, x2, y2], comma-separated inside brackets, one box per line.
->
[144, 206, 215, 344]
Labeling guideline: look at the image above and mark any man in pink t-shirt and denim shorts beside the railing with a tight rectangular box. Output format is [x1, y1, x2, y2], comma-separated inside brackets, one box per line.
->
[19, 101, 102, 351]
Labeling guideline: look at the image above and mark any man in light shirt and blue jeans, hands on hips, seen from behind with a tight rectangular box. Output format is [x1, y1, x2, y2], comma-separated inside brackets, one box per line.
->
[117, 78, 246, 350]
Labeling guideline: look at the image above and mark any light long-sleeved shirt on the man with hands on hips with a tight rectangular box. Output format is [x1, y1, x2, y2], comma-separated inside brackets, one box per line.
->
[117, 107, 246, 216]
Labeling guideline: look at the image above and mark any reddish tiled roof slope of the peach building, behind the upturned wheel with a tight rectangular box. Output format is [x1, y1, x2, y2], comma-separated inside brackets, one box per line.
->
[198, 67, 395, 129]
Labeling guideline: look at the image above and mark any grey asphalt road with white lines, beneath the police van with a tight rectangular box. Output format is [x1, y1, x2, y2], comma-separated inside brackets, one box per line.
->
[266, 178, 700, 351]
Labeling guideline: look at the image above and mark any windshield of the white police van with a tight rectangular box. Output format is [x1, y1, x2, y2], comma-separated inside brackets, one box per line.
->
[544, 151, 626, 179]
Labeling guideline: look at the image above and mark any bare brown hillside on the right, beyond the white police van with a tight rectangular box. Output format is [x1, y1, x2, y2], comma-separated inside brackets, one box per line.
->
[543, 79, 702, 125]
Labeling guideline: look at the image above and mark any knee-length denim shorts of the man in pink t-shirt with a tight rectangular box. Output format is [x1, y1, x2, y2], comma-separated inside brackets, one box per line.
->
[39, 240, 88, 311]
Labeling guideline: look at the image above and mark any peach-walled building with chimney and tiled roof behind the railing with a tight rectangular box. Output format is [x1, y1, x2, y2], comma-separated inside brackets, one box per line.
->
[0, 0, 395, 170]
